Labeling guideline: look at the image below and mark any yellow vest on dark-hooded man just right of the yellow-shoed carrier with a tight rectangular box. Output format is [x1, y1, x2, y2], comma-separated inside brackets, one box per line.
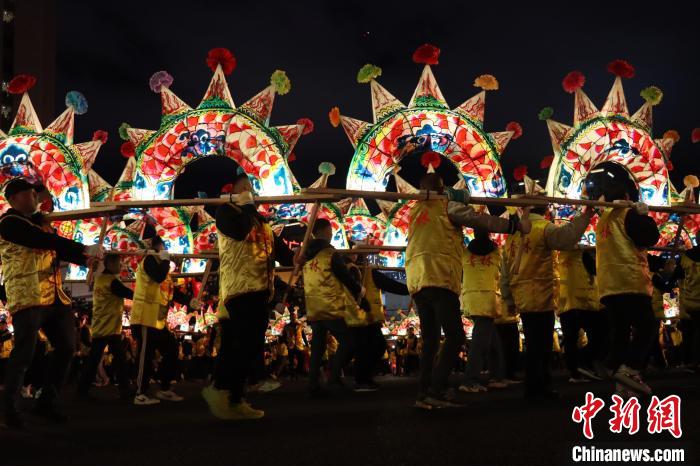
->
[303, 246, 364, 325]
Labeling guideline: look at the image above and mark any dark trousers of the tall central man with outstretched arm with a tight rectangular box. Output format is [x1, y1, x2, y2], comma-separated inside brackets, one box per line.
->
[413, 287, 466, 396]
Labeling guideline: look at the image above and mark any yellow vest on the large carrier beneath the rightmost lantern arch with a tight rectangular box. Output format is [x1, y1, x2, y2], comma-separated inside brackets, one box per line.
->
[595, 208, 652, 299]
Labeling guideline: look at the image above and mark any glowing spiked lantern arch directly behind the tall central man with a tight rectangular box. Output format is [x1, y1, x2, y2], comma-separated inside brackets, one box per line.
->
[329, 44, 522, 265]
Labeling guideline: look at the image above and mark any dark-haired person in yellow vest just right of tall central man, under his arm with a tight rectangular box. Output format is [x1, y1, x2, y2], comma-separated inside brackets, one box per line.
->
[459, 228, 507, 393]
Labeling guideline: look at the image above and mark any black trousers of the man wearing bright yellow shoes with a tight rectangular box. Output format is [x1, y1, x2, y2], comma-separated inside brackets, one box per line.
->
[214, 290, 269, 403]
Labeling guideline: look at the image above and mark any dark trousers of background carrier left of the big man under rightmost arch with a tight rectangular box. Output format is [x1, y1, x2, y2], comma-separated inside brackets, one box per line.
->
[559, 309, 607, 377]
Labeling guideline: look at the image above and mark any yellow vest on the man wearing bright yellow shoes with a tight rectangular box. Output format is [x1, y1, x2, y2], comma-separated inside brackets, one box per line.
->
[218, 210, 275, 319]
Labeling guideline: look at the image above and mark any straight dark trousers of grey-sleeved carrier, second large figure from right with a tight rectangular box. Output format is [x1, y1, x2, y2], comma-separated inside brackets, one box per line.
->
[520, 311, 554, 394]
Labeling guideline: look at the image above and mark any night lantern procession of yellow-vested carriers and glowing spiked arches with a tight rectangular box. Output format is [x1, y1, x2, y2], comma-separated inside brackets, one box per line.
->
[0, 5, 700, 464]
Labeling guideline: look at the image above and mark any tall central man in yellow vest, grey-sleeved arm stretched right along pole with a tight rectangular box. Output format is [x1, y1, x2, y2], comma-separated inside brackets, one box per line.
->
[406, 173, 529, 409]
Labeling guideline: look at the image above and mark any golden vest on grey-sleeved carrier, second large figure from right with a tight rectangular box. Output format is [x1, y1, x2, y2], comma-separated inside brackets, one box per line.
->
[507, 216, 559, 313]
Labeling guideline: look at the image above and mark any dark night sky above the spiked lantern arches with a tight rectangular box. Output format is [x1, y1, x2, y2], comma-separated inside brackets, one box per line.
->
[56, 0, 700, 197]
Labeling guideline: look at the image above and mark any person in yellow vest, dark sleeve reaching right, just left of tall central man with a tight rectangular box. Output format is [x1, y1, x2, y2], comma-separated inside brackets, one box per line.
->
[346, 246, 408, 392]
